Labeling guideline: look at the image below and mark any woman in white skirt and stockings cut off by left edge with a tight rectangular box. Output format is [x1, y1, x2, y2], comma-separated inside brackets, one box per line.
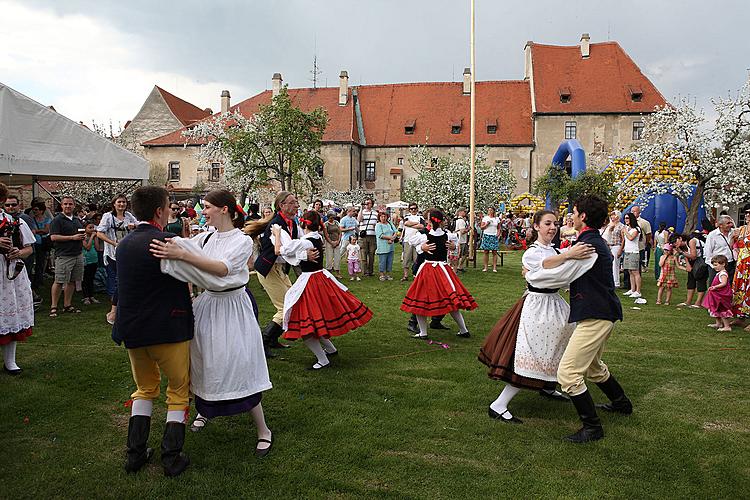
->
[0, 182, 36, 375]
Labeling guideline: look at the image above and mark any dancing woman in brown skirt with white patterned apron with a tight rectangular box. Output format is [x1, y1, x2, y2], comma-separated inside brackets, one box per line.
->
[479, 210, 593, 424]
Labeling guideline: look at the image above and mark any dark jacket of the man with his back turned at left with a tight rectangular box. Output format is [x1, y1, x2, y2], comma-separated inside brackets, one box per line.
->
[112, 224, 193, 349]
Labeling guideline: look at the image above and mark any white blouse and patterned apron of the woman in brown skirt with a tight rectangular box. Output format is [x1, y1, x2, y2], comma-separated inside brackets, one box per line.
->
[513, 241, 576, 382]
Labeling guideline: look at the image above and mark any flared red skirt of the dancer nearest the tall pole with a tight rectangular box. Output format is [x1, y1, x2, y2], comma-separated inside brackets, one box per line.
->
[401, 261, 477, 316]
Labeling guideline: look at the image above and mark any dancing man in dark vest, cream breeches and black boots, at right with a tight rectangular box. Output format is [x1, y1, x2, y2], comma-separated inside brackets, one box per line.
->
[526, 196, 633, 443]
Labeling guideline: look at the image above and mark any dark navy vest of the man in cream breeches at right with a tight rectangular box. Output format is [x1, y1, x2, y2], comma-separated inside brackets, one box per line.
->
[568, 229, 622, 323]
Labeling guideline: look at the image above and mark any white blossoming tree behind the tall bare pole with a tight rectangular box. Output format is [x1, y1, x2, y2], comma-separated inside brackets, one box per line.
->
[402, 146, 516, 213]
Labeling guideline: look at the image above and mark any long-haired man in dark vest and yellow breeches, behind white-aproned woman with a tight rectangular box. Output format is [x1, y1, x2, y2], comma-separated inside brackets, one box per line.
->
[255, 191, 318, 358]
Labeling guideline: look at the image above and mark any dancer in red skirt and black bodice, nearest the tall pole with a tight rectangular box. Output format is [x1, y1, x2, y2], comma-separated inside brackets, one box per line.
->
[401, 210, 477, 339]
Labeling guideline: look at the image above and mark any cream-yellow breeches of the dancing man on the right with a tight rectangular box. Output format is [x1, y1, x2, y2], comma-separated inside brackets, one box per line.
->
[557, 319, 615, 396]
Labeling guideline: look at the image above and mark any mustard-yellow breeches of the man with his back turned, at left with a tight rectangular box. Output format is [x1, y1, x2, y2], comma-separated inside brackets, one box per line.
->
[128, 340, 190, 411]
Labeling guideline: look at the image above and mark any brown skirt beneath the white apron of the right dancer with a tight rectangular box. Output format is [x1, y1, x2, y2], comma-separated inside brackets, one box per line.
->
[478, 294, 556, 390]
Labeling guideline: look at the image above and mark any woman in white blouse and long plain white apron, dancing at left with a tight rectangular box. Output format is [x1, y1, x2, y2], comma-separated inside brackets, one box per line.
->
[151, 190, 272, 457]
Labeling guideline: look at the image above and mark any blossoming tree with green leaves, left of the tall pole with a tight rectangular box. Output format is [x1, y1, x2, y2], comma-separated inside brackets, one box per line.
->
[183, 87, 328, 203]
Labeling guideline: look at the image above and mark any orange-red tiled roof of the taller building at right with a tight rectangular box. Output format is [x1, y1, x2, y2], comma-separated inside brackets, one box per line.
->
[531, 42, 666, 114]
